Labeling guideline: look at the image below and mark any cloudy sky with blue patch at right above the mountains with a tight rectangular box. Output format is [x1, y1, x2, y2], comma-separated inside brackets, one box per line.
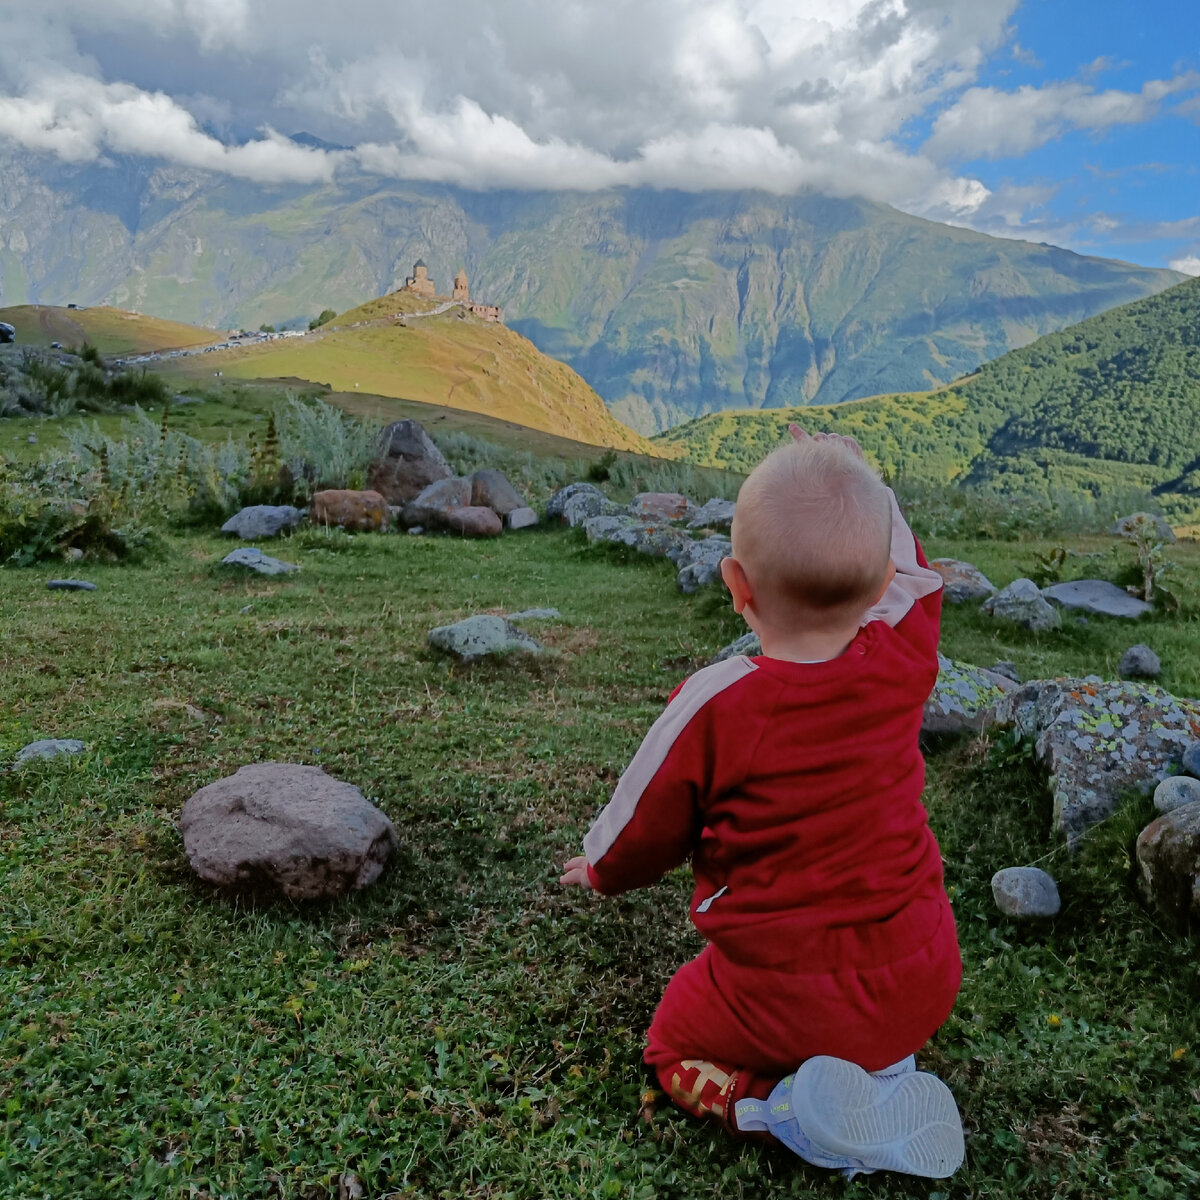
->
[0, 0, 1200, 275]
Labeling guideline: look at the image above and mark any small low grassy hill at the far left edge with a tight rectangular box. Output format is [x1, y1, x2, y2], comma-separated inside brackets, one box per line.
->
[0, 305, 221, 354]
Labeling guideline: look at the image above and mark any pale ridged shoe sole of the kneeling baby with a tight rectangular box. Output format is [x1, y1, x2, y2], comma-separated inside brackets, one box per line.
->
[792, 1056, 965, 1180]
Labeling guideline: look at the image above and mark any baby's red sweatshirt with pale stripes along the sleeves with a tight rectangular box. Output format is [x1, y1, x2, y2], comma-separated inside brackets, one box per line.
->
[583, 497, 948, 972]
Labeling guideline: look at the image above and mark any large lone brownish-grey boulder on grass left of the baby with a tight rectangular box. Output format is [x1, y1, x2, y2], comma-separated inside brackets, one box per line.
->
[180, 762, 396, 900]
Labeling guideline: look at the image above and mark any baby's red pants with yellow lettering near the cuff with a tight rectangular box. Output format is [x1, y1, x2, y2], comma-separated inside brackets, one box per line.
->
[646, 906, 962, 1128]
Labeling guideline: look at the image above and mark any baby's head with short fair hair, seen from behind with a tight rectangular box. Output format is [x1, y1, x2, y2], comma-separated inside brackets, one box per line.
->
[733, 438, 892, 629]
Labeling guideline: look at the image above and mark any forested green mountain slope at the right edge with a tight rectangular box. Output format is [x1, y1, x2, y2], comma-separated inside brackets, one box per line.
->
[655, 278, 1200, 520]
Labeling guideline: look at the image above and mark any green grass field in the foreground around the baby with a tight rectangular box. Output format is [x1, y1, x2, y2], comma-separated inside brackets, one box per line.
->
[0, 518, 1200, 1200]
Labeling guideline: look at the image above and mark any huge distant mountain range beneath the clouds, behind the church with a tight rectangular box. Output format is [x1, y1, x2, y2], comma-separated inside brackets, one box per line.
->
[0, 151, 1182, 431]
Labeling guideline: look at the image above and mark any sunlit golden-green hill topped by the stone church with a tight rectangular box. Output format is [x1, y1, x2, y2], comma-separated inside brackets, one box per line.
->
[158, 294, 653, 452]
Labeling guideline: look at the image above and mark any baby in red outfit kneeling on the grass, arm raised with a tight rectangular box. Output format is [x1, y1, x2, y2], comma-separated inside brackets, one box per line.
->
[560, 426, 964, 1177]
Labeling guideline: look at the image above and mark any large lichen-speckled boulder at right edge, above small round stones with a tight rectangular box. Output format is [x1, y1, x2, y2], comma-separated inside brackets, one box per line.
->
[996, 679, 1200, 845]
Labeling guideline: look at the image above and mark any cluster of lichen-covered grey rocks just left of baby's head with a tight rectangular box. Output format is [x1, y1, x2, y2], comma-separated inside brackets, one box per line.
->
[546, 482, 736, 593]
